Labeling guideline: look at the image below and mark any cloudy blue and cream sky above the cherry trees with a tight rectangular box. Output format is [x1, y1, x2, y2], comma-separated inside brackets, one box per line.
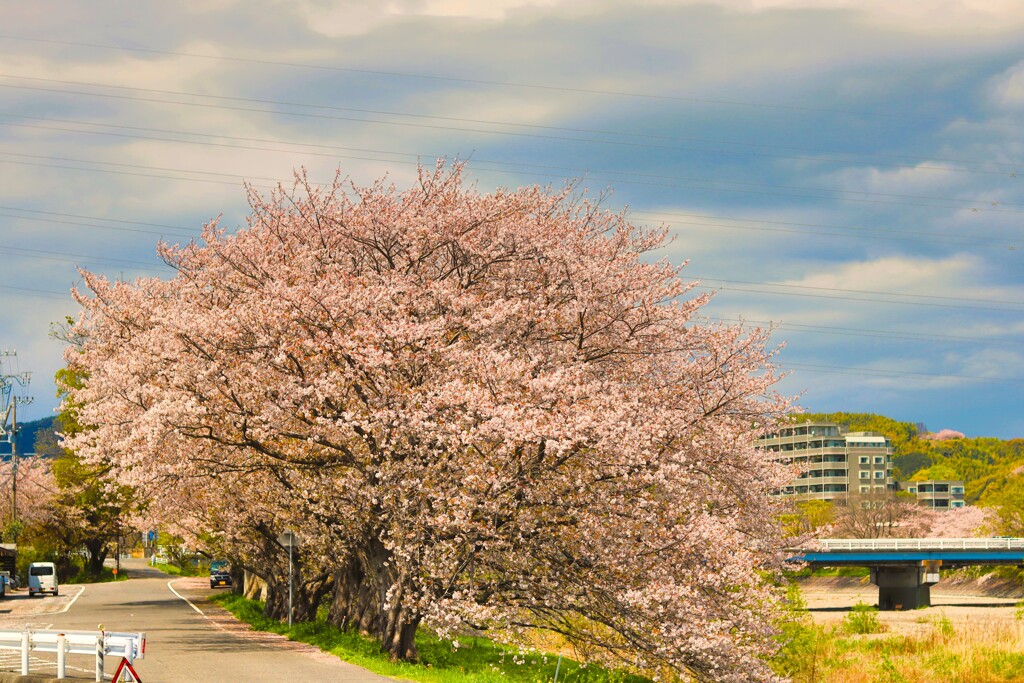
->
[0, 0, 1024, 438]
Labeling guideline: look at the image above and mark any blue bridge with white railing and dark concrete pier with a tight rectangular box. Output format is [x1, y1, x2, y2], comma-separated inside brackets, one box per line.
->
[790, 539, 1024, 609]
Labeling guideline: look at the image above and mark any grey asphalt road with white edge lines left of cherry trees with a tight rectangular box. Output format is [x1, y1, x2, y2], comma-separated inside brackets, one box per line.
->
[0, 560, 393, 683]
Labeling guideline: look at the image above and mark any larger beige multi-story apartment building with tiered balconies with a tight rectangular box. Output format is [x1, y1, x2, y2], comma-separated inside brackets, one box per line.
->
[757, 422, 896, 504]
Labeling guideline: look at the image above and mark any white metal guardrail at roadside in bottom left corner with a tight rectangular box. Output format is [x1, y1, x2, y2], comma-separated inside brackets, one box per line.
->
[0, 630, 145, 681]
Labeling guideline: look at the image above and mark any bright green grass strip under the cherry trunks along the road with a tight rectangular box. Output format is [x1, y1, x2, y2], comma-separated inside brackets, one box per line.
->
[211, 593, 649, 683]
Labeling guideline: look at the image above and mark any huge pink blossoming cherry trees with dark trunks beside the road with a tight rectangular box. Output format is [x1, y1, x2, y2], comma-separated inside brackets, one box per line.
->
[67, 164, 786, 681]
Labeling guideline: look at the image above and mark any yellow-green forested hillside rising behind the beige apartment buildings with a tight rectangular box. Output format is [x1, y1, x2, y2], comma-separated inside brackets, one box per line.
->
[797, 413, 1024, 504]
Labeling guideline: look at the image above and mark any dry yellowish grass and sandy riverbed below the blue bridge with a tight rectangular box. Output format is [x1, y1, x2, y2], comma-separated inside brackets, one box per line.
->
[778, 577, 1024, 683]
